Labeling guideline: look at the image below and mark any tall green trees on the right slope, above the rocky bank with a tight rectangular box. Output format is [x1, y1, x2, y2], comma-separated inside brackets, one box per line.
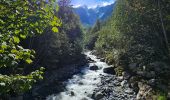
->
[93, 0, 170, 63]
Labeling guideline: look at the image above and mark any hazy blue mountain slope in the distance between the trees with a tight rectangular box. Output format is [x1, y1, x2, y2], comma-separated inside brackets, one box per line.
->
[74, 3, 115, 26]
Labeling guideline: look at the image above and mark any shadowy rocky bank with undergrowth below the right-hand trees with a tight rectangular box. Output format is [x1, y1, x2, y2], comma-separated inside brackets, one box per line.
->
[92, 50, 170, 100]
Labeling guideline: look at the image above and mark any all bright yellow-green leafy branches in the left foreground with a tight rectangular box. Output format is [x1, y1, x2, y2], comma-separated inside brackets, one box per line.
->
[0, 0, 61, 95]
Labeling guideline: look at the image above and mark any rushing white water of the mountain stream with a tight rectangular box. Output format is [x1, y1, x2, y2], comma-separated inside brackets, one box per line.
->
[47, 52, 109, 100]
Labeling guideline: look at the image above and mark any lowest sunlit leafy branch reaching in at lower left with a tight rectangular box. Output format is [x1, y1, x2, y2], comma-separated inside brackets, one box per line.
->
[0, 68, 43, 95]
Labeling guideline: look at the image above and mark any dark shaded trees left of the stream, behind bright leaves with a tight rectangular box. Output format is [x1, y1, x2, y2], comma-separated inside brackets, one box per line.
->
[26, 0, 83, 72]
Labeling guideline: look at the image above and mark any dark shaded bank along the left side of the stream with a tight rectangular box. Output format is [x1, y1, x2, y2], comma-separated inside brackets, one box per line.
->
[23, 55, 88, 100]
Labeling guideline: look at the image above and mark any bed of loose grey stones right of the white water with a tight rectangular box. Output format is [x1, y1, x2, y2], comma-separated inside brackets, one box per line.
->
[92, 74, 136, 100]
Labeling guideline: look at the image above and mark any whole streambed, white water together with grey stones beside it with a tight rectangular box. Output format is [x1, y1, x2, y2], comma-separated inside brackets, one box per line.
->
[46, 52, 136, 100]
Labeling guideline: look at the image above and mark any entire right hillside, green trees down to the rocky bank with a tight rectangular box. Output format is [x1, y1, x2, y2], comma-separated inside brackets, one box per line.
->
[85, 0, 170, 100]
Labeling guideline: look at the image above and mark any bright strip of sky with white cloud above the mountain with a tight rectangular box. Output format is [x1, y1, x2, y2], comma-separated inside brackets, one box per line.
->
[72, 0, 115, 8]
